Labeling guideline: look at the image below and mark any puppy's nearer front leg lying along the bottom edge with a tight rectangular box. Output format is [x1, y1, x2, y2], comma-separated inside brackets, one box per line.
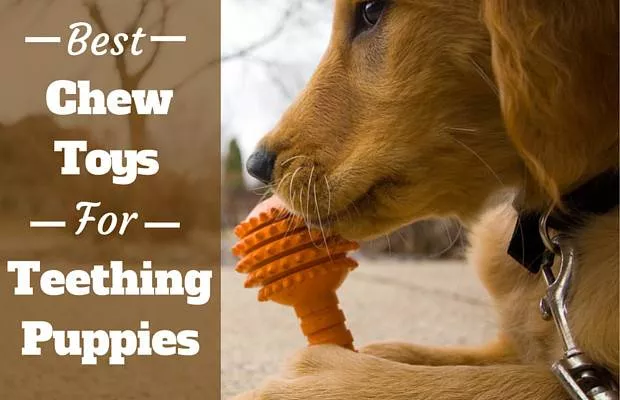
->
[237, 346, 568, 400]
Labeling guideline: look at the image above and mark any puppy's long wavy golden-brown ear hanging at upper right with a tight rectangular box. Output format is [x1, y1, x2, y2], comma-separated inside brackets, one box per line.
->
[483, 0, 618, 202]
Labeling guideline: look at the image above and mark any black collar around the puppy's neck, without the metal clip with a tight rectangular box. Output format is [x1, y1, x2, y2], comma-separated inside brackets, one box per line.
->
[508, 169, 619, 273]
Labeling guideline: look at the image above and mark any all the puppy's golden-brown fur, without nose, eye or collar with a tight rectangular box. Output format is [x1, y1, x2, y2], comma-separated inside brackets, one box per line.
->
[235, 0, 619, 400]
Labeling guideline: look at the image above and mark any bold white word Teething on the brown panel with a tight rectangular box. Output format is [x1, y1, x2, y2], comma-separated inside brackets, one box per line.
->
[7, 261, 213, 306]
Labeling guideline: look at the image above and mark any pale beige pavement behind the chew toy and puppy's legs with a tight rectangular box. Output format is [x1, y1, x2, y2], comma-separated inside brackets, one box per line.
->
[222, 258, 496, 399]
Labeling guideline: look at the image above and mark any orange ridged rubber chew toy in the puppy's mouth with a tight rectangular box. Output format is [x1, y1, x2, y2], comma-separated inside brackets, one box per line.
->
[232, 203, 359, 349]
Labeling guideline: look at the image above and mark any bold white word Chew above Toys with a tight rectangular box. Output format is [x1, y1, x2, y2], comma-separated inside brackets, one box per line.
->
[45, 80, 174, 115]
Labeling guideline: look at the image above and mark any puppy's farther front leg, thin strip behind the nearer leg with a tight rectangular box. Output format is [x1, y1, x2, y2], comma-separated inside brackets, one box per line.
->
[360, 339, 518, 366]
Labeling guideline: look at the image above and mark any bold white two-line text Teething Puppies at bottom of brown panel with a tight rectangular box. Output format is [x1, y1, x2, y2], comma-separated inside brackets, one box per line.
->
[7, 261, 212, 365]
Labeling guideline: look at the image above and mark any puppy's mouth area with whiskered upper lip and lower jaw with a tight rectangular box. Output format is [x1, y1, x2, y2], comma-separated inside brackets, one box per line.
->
[262, 157, 410, 239]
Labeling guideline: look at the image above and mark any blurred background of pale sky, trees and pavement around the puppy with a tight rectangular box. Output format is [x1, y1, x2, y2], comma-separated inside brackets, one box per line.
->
[221, 0, 495, 398]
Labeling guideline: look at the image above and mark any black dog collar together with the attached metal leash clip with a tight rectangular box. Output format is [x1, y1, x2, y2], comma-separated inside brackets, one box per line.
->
[508, 170, 619, 400]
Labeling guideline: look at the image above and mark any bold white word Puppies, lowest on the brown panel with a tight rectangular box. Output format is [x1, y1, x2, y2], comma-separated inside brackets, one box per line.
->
[22, 321, 200, 365]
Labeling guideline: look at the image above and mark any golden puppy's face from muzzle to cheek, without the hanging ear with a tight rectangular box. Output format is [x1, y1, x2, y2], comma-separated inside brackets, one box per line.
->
[251, 0, 524, 239]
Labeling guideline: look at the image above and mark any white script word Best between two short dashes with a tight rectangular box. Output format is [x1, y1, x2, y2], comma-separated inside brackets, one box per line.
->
[67, 22, 146, 56]
